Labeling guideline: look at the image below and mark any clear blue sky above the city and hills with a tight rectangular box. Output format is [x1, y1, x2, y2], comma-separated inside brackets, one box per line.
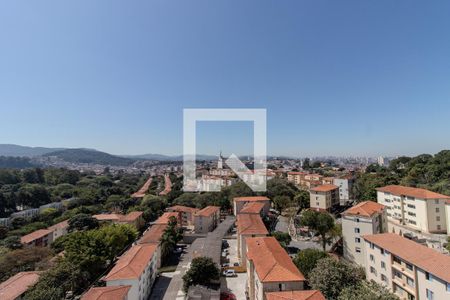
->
[0, 0, 450, 156]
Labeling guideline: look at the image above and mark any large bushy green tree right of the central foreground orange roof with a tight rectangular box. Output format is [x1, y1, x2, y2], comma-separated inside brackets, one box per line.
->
[309, 257, 364, 299]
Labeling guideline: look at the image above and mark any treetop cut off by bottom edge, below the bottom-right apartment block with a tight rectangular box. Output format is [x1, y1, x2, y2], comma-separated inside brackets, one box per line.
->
[338, 280, 399, 300]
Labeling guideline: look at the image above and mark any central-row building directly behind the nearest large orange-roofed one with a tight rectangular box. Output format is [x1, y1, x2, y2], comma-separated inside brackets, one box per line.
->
[236, 214, 269, 266]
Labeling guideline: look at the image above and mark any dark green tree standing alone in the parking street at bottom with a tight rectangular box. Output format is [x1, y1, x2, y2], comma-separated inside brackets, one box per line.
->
[183, 257, 220, 292]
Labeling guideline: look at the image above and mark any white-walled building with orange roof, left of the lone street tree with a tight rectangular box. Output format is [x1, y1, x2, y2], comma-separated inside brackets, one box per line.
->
[104, 244, 158, 300]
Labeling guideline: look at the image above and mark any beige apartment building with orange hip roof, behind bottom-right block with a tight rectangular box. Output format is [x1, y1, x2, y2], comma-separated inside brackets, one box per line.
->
[342, 201, 387, 266]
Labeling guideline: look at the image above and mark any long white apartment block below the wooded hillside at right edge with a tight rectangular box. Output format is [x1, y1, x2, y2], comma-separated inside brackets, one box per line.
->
[377, 185, 450, 233]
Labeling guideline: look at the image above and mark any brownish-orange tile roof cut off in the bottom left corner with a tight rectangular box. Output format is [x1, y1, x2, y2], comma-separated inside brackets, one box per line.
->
[0, 271, 40, 300]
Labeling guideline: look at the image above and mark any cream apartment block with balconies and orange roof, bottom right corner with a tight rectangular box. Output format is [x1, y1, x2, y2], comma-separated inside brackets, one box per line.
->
[363, 233, 450, 300]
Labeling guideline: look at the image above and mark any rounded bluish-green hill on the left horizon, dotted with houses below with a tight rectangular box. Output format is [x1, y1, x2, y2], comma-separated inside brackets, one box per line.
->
[43, 149, 135, 166]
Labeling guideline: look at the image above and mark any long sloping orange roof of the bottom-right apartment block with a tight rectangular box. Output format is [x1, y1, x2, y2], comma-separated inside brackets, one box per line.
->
[363, 233, 450, 282]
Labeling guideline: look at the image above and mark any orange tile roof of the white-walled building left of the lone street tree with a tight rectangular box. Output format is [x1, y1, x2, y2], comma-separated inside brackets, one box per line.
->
[105, 244, 158, 281]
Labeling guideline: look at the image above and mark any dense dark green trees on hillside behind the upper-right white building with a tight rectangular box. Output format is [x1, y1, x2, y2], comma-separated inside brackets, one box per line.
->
[353, 150, 450, 201]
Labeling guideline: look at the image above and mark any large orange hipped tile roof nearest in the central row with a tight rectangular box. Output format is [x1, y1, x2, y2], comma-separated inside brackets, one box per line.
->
[246, 236, 305, 282]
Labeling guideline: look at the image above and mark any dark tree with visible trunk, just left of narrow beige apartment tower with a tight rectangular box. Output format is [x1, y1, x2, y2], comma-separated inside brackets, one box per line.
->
[300, 210, 336, 251]
